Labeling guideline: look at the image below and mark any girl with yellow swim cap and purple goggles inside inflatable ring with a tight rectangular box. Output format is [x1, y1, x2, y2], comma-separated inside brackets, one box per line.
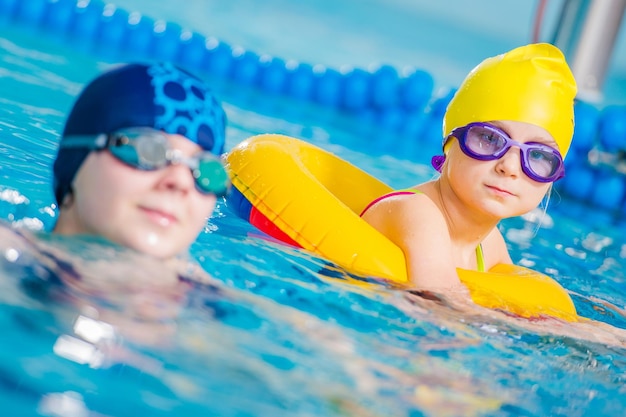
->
[362, 44, 576, 292]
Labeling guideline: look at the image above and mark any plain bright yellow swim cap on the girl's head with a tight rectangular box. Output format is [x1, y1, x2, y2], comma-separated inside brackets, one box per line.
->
[443, 43, 576, 157]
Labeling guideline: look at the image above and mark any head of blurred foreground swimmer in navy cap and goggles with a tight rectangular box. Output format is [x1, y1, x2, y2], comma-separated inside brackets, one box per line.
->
[53, 64, 229, 259]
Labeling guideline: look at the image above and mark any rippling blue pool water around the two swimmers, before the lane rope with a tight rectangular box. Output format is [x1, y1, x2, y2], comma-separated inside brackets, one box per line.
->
[0, 2, 626, 417]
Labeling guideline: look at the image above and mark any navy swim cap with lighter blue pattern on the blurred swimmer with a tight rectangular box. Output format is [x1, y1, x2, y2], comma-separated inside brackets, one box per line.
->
[53, 63, 226, 205]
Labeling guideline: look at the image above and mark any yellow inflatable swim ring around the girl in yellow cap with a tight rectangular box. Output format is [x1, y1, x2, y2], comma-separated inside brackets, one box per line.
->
[227, 134, 578, 321]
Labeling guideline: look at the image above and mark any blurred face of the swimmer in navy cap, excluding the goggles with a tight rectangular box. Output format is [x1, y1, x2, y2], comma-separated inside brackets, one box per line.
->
[60, 135, 216, 258]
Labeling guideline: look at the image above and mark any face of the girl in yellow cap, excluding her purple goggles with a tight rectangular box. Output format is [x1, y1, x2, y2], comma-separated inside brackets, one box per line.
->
[445, 121, 557, 218]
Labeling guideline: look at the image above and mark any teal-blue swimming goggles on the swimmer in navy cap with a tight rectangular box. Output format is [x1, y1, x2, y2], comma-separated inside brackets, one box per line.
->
[60, 127, 230, 197]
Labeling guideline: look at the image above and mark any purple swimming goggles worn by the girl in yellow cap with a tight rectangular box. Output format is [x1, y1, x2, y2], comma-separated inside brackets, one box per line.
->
[431, 123, 565, 182]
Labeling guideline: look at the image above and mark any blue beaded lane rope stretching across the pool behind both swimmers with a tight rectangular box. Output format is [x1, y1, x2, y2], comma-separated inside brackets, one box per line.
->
[0, 0, 626, 215]
